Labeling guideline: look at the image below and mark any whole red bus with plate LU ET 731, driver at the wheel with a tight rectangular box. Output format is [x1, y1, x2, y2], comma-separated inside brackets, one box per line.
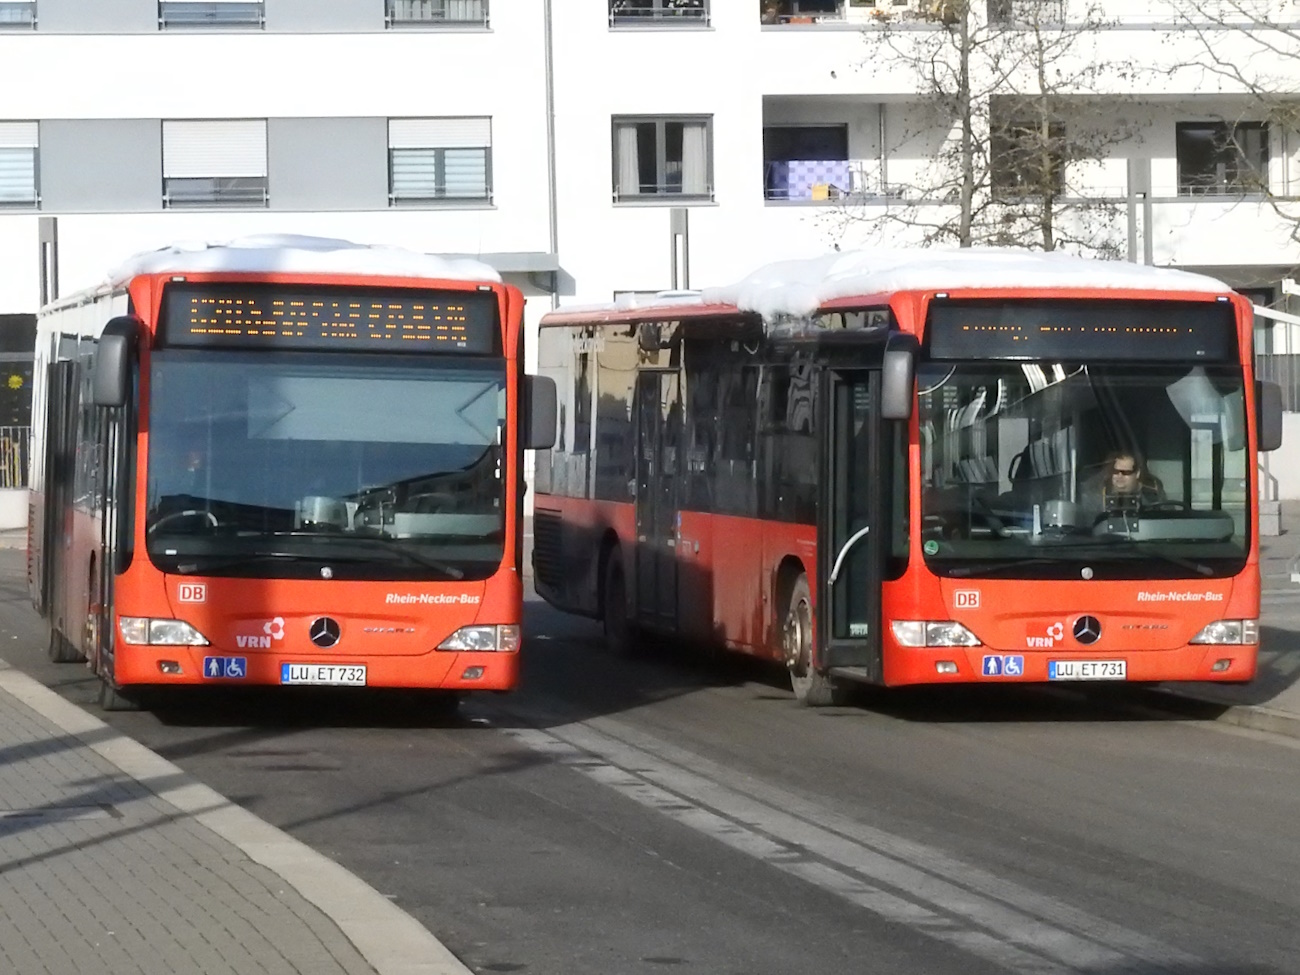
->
[533, 250, 1282, 705]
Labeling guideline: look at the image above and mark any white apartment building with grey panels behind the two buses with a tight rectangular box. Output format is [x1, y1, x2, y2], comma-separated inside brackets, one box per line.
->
[0, 0, 1300, 498]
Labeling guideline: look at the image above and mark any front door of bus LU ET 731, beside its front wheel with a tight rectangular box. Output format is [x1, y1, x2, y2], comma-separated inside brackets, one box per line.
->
[816, 369, 885, 681]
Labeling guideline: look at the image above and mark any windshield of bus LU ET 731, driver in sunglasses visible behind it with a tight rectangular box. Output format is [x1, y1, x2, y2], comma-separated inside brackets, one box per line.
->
[917, 360, 1251, 579]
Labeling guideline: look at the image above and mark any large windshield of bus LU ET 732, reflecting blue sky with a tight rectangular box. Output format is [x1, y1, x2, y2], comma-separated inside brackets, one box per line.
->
[146, 350, 506, 580]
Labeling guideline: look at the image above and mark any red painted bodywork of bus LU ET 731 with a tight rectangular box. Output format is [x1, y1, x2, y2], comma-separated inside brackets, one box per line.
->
[534, 280, 1260, 686]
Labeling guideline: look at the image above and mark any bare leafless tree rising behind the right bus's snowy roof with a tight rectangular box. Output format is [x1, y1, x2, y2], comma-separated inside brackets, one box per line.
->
[837, 0, 1134, 256]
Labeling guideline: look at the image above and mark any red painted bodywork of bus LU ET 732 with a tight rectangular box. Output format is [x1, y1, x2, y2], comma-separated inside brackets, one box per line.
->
[29, 272, 524, 690]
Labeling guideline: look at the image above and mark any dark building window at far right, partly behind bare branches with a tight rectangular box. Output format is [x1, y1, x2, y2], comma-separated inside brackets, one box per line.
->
[1175, 122, 1269, 196]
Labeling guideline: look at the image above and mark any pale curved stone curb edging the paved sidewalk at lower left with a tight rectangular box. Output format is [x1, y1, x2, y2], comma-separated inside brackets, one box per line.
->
[0, 659, 472, 975]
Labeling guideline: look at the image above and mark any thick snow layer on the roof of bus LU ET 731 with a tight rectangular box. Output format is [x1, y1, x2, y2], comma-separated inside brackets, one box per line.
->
[699, 247, 1232, 320]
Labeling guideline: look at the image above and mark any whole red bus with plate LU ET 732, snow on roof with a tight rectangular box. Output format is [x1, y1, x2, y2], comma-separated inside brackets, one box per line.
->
[27, 237, 555, 710]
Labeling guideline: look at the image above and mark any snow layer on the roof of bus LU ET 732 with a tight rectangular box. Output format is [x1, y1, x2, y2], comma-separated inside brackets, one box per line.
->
[108, 234, 501, 287]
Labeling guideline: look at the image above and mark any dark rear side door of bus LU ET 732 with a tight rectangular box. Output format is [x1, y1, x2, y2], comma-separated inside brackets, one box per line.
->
[36, 359, 77, 623]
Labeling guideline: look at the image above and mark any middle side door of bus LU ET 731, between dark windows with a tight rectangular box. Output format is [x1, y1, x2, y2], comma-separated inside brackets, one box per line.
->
[633, 369, 681, 629]
